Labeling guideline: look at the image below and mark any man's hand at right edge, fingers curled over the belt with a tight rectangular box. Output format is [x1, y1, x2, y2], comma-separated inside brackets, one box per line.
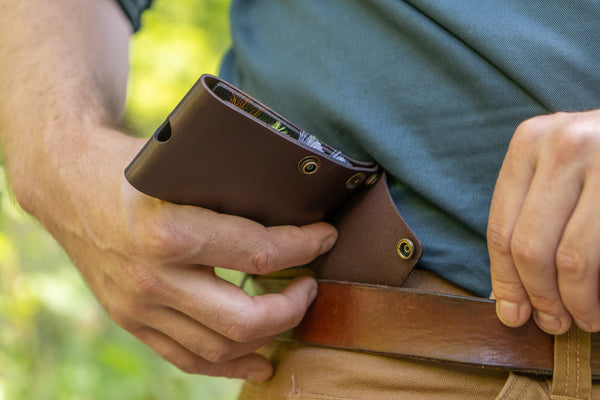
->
[488, 110, 600, 334]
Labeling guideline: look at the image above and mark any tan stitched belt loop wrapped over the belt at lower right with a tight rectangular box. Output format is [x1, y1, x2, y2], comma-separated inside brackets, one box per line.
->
[550, 324, 592, 400]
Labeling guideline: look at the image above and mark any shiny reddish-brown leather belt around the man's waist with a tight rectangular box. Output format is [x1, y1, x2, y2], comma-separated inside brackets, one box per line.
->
[288, 281, 600, 378]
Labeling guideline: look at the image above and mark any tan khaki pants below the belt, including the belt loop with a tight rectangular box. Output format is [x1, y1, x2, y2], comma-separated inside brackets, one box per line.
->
[240, 332, 600, 400]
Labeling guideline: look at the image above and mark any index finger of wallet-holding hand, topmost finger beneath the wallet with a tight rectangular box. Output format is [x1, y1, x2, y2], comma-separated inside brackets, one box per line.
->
[162, 205, 337, 274]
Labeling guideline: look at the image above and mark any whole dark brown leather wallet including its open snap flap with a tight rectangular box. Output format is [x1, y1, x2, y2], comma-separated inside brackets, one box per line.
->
[125, 75, 422, 286]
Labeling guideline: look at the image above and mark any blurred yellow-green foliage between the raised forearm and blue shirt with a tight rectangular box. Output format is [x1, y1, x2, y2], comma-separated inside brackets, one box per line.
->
[127, 0, 230, 136]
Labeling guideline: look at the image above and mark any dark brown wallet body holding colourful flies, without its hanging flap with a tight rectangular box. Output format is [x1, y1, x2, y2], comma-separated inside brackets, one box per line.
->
[125, 75, 380, 226]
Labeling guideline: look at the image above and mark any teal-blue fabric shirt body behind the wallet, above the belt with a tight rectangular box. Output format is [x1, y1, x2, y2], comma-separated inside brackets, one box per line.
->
[118, 0, 600, 297]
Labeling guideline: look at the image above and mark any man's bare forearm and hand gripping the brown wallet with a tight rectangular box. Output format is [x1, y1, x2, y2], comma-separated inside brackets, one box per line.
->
[0, 0, 336, 380]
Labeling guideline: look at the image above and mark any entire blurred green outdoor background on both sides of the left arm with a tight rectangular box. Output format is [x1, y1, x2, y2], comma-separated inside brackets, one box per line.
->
[0, 0, 240, 400]
